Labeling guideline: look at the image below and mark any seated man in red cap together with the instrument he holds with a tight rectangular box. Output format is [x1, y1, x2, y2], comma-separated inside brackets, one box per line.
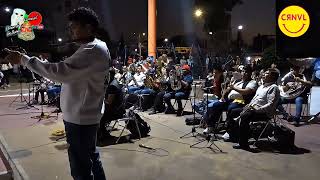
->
[163, 65, 193, 116]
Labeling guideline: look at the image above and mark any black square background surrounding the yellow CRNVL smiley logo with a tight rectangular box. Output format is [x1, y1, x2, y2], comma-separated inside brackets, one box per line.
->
[276, 0, 320, 58]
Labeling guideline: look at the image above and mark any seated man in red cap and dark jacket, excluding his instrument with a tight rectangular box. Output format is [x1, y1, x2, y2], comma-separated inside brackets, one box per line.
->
[163, 65, 193, 116]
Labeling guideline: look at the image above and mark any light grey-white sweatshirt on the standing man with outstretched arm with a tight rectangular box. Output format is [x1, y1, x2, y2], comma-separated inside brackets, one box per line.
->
[21, 39, 110, 125]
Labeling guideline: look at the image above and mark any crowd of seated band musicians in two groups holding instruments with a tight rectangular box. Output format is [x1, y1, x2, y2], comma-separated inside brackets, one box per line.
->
[101, 50, 317, 149]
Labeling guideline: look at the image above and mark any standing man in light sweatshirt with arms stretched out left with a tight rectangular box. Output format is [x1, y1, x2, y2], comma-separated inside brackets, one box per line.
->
[6, 8, 110, 180]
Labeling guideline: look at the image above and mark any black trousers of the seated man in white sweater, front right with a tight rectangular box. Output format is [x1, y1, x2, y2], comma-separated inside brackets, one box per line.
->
[239, 111, 269, 146]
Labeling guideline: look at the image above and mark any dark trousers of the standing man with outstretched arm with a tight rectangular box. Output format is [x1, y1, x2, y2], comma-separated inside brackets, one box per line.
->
[64, 121, 106, 180]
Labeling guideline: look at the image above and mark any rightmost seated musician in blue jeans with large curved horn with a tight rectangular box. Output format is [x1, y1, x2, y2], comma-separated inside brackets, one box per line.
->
[278, 65, 312, 126]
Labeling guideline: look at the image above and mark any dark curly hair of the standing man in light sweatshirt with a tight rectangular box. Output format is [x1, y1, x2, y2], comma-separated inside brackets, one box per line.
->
[68, 7, 100, 30]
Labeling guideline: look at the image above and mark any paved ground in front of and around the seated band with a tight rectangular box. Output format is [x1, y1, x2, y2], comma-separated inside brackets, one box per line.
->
[0, 83, 320, 180]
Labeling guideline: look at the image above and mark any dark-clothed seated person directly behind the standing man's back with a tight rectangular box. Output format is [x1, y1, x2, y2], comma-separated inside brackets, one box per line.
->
[98, 69, 125, 140]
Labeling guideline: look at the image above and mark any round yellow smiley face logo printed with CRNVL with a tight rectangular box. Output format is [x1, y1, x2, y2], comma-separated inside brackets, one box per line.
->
[278, 6, 310, 37]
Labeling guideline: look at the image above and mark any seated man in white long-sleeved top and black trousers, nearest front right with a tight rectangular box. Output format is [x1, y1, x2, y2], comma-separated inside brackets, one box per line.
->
[227, 68, 280, 150]
